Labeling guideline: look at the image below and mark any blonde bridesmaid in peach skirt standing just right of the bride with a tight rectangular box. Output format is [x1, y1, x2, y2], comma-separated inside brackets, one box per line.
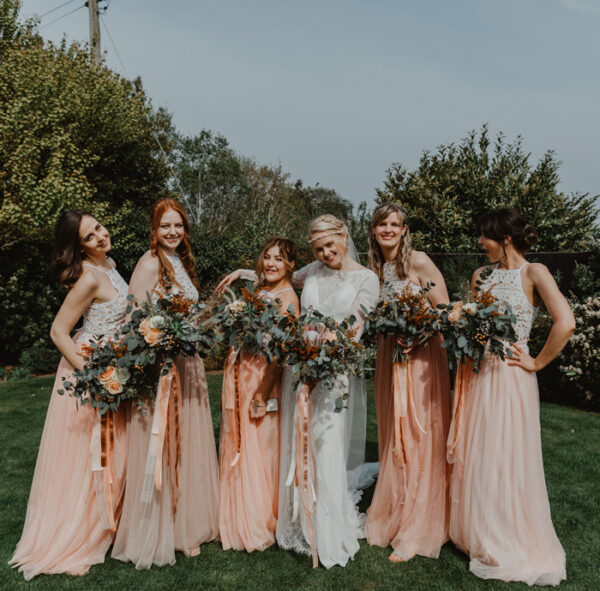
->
[365, 202, 450, 562]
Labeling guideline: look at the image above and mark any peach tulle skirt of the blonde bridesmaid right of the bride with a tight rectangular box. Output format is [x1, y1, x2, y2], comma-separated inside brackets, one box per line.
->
[365, 337, 450, 560]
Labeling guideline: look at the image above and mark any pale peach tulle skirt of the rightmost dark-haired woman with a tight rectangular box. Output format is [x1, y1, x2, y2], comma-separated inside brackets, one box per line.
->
[448, 355, 566, 585]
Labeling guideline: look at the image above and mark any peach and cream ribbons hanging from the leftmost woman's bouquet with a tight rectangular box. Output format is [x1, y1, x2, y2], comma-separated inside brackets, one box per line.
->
[90, 410, 116, 531]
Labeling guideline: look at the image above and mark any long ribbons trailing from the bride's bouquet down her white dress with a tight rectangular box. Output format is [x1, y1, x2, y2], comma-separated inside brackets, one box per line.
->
[295, 384, 319, 568]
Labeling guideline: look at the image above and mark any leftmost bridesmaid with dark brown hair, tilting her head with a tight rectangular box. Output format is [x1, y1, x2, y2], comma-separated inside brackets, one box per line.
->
[9, 210, 127, 580]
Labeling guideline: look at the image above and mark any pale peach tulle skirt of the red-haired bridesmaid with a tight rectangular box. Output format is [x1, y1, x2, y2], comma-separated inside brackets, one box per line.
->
[112, 356, 219, 569]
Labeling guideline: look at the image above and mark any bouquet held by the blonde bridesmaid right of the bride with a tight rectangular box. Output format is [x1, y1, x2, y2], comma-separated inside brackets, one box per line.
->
[363, 284, 440, 362]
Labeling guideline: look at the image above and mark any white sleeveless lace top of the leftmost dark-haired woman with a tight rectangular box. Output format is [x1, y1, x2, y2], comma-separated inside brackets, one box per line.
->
[80, 265, 128, 338]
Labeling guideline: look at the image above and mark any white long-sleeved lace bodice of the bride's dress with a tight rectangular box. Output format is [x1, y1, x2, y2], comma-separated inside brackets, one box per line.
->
[301, 261, 379, 324]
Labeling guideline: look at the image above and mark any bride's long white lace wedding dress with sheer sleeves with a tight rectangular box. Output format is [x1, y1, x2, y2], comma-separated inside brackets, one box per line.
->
[277, 261, 379, 568]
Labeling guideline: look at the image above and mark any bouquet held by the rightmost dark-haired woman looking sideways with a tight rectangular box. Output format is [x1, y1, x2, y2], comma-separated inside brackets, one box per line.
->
[438, 281, 517, 373]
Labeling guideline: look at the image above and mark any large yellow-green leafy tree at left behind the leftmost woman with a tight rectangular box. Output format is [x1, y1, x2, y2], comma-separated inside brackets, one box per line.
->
[0, 0, 170, 360]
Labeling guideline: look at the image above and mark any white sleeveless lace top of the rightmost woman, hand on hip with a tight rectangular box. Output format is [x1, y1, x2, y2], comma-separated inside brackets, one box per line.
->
[481, 263, 537, 343]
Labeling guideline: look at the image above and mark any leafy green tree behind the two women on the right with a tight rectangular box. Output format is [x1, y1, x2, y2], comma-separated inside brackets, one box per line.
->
[377, 125, 599, 252]
